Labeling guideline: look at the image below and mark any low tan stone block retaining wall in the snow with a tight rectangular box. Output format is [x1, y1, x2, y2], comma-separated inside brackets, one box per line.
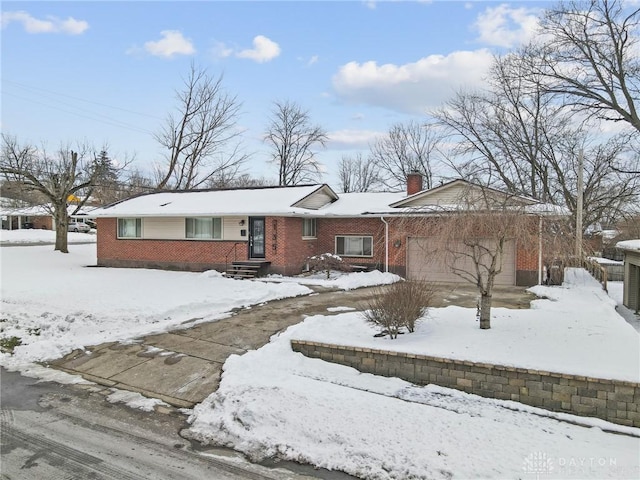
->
[291, 340, 640, 427]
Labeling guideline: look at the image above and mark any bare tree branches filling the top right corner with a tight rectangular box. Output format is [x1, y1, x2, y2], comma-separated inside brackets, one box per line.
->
[530, 0, 640, 131]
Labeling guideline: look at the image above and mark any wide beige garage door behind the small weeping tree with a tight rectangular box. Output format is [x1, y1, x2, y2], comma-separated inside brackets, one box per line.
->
[407, 237, 516, 285]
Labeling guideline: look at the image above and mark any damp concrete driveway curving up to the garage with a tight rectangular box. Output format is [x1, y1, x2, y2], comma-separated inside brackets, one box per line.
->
[50, 286, 534, 408]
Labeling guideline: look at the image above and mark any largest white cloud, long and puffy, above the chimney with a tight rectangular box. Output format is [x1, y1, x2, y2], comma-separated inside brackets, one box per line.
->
[333, 49, 493, 113]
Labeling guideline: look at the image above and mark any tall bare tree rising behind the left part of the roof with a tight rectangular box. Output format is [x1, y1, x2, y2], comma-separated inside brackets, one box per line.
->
[155, 64, 247, 190]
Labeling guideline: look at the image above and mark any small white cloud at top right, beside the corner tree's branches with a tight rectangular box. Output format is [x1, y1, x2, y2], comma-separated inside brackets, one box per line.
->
[474, 4, 540, 48]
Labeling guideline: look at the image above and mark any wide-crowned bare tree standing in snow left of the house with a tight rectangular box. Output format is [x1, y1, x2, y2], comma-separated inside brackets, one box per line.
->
[0, 135, 104, 253]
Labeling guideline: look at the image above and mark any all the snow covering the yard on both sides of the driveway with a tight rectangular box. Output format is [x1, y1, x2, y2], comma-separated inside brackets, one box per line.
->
[0, 240, 640, 479]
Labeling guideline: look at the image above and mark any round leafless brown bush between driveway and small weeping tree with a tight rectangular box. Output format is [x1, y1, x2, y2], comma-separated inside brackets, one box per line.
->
[362, 281, 435, 338]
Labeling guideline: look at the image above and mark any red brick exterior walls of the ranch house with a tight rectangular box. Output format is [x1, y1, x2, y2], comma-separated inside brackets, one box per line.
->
[98, 217, 538, 285]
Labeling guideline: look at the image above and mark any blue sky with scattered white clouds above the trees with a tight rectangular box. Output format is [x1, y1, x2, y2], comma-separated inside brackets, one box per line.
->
[0, 1, 552, 184]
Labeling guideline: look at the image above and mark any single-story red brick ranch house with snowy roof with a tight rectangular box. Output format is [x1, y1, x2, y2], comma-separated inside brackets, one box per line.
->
[92, 175, 564, 286]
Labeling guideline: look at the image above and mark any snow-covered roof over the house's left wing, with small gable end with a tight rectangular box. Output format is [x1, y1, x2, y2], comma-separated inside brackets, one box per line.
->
[92, 184, 337, 217]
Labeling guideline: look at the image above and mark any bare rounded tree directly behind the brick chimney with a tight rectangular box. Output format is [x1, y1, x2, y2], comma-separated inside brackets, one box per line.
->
[371, 121, 440, 189]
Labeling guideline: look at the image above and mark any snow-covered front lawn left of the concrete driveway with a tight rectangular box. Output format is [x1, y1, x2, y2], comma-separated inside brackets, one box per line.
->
[0, 244, 311, 368]
